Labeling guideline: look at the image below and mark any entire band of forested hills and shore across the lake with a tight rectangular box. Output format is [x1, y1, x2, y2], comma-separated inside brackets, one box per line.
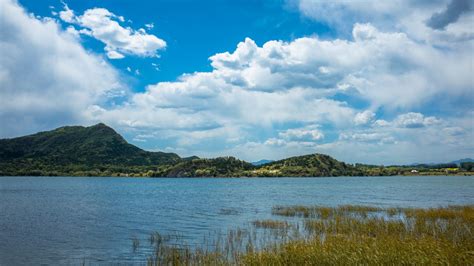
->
[0, 123, 474, 177]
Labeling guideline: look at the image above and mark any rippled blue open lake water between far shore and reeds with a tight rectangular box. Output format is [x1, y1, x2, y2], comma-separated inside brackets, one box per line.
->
[0, 176, 474, 265]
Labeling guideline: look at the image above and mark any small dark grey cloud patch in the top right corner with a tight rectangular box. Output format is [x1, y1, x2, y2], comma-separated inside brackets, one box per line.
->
[426, 0, 473, 30]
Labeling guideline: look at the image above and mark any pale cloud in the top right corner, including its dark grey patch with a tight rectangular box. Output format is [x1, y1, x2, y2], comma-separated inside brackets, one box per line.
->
[294, 0, 474, 46]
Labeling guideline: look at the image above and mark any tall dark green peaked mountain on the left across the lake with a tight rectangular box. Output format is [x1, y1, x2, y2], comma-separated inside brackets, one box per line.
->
[0, 123, 181, 174]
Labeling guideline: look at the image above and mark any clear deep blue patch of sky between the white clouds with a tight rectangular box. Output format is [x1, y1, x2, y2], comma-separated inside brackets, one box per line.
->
[20, 0, 334, 91]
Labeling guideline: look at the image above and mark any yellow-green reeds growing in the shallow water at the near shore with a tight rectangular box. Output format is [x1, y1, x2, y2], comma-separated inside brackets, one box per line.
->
[135, 205, 474, 265]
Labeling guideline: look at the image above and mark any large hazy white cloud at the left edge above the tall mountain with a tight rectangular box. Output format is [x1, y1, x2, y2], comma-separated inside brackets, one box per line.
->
[0, 0, 123, 137]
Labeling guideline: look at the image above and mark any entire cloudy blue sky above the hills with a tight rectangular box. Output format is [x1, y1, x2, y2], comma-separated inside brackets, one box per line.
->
[0, 0, 474, 165]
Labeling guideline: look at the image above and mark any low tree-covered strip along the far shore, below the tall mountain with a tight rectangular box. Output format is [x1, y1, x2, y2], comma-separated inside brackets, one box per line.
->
[0, 154, 474, 177]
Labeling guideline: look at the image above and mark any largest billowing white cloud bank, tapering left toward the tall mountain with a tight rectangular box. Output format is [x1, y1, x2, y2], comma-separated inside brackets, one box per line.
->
[88, 24, 472, 160]
